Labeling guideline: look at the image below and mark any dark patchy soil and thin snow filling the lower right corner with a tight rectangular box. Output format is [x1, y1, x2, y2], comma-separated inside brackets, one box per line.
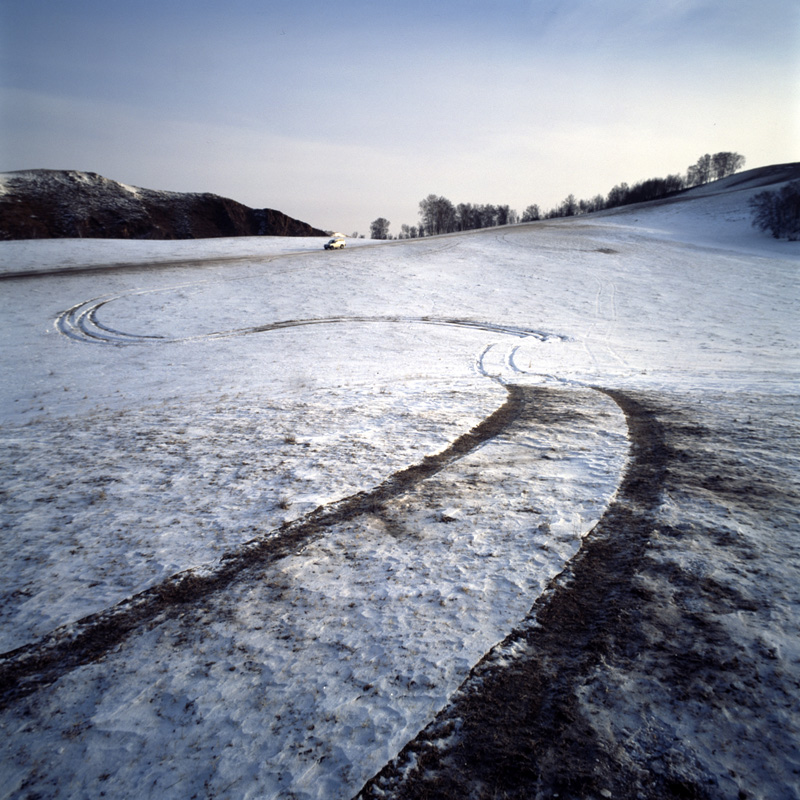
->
[359, 392, 800, 800]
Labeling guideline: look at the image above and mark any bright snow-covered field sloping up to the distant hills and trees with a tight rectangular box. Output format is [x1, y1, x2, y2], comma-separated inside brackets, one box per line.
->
[0, 177, 800, 798]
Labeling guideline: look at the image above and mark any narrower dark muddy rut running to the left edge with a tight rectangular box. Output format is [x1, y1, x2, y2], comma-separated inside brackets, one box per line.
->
[0, 386, 532, 707]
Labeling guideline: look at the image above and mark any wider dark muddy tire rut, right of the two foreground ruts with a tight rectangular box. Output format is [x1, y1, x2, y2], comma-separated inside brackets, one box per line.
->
[358, 389, 672, 800]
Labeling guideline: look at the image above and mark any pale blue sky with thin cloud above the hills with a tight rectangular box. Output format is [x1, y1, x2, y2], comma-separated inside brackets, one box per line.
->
[0, 0, 800, 235]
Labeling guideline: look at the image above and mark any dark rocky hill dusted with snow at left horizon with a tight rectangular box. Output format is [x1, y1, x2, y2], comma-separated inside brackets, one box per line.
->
[0, 169, 325, 239]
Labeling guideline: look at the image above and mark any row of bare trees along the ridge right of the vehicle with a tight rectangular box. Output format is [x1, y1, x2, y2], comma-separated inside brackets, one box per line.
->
[370, 152, 745, 239]
